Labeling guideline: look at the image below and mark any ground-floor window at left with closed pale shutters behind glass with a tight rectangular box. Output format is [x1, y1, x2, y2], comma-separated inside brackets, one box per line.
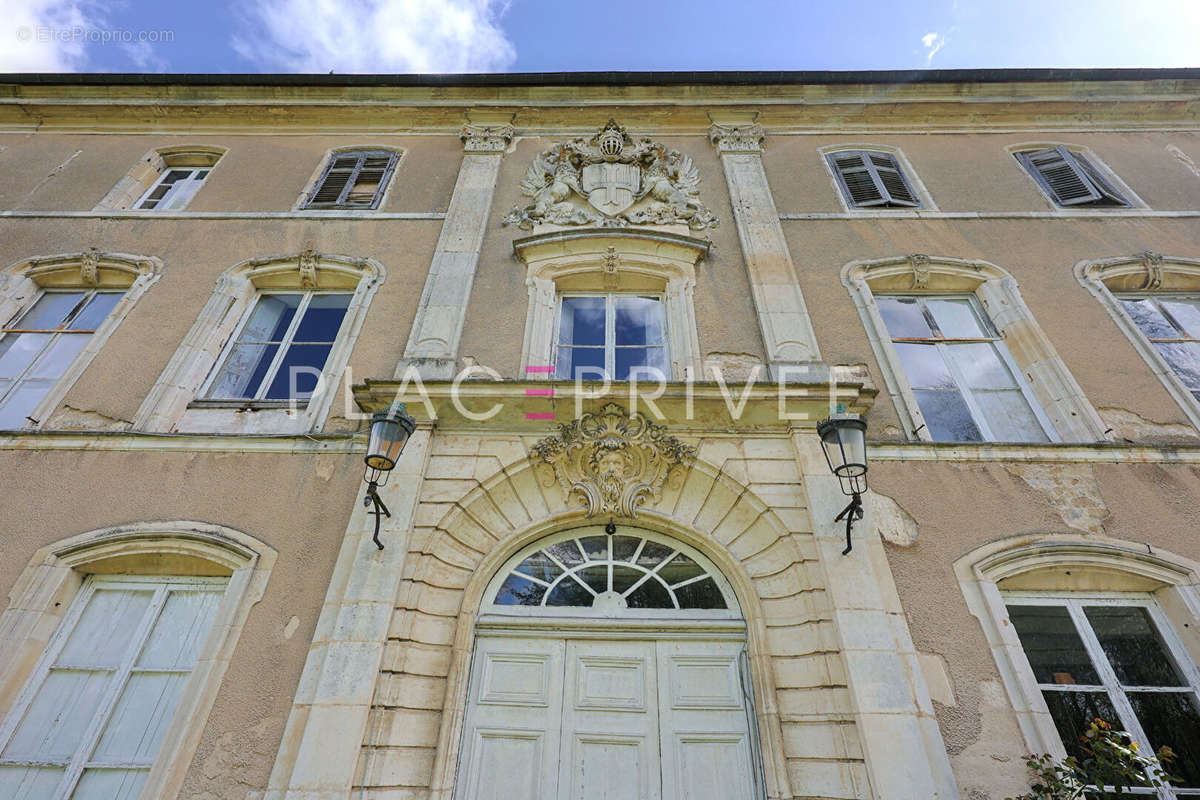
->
[0, 576, 228, 800]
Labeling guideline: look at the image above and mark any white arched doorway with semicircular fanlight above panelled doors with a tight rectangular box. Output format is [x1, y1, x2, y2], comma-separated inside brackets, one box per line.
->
[455, 525, 763, 800]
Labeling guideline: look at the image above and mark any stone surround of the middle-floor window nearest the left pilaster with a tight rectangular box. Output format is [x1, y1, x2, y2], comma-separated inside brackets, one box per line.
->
[133, 251, 386, 433]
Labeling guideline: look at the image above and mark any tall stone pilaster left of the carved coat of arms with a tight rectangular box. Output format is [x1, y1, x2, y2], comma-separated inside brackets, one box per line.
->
[396, 124, 514, 380]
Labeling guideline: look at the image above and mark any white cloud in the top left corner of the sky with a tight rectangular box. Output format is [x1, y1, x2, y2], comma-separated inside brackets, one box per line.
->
[0, 0, 101, 72]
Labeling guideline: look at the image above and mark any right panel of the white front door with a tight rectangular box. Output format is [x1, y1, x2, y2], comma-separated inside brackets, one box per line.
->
[656, 640, 757, 800]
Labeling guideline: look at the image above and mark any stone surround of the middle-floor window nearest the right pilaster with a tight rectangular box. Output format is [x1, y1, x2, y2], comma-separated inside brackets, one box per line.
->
[841, 254, 1108, 443]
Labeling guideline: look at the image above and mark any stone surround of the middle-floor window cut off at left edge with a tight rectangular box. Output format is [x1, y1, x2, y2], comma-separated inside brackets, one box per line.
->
[0, 248, 162, 428]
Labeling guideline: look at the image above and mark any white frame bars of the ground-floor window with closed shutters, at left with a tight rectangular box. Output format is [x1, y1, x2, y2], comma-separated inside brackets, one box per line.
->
[0, 575, 229, 800]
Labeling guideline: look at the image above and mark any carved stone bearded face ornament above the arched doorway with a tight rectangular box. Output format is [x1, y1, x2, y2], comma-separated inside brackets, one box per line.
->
[530, 403, 696, 518]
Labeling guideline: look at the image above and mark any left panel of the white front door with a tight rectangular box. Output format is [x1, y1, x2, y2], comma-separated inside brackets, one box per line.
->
[456, 636, 566, 800]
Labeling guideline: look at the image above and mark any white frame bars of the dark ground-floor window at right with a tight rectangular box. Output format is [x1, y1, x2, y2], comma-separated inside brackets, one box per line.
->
[1000, 590, 1200, 800]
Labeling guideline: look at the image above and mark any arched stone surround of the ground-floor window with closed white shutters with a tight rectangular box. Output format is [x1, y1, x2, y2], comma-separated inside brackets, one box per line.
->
[0, 521, 276, 798]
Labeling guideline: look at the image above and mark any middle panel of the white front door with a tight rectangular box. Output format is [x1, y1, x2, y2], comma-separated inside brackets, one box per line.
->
[559, 640, 660, 800]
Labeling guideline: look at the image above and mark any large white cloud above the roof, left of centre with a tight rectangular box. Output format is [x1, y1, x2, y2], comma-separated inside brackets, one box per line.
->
[233, 0, 516, 73]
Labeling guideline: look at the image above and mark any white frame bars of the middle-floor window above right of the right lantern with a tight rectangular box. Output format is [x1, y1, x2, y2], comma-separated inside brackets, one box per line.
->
[875, 291, 1060, 444]
